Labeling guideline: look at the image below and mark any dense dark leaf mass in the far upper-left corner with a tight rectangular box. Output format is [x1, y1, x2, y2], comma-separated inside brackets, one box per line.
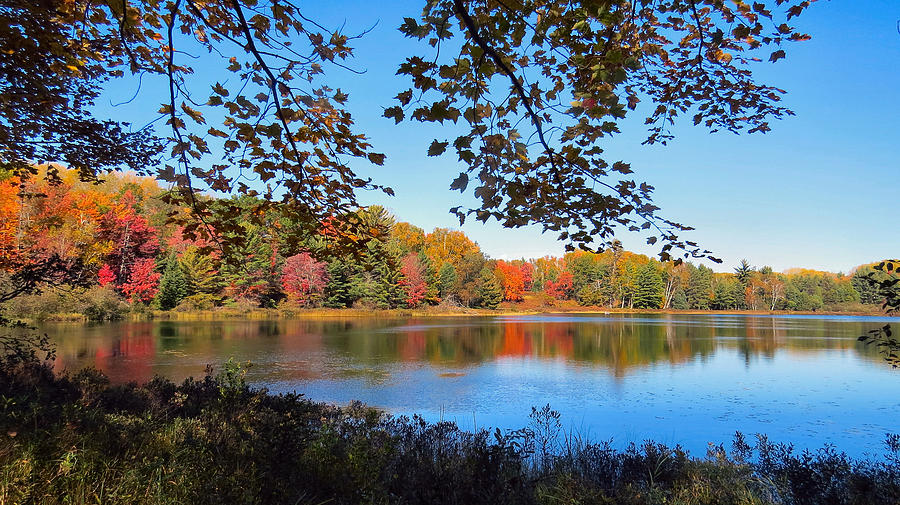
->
[0, 0, 162, 180]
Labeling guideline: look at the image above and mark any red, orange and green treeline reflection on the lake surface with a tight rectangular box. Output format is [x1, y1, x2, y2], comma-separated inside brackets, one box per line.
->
[43, 315, 882, 382]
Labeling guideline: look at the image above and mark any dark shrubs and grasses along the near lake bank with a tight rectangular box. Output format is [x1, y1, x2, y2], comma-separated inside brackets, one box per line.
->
[0, 334, 900, 504]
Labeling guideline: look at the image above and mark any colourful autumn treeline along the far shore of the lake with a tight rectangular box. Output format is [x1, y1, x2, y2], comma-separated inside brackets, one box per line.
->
[0, 171, 879, 319]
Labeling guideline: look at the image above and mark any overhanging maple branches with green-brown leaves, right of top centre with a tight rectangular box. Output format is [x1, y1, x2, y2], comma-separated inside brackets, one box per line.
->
[394, 0, 810, 261]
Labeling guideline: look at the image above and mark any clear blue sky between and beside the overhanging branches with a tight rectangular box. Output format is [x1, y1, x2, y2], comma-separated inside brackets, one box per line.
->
[95, 0, 900, 272]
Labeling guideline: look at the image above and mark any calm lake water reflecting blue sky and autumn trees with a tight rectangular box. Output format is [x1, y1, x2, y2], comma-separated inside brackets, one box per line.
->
[42, 314, 900, 456]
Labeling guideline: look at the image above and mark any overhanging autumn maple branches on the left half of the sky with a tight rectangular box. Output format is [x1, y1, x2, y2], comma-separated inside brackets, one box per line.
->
[0, 0, 391, 260]
